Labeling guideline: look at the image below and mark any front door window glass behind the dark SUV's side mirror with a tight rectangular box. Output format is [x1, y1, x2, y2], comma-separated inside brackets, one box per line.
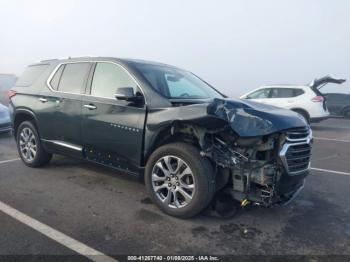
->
[91, 63, 139, 98]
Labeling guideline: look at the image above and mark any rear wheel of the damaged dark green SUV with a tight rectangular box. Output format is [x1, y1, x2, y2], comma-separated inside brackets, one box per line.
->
[16, 121, 52, 167]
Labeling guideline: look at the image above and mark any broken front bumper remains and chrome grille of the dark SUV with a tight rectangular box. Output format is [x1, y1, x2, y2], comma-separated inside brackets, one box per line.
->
[232, 126, 312, 206]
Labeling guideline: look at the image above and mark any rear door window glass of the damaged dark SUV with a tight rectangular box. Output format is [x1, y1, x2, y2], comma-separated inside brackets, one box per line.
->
[56, 63, 90, 94]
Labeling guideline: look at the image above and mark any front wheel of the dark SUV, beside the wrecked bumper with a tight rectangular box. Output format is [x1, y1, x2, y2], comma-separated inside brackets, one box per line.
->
[145, 143, 215, 218]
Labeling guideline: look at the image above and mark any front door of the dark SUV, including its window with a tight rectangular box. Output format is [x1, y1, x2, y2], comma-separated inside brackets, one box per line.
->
[82, 62, 146, 172]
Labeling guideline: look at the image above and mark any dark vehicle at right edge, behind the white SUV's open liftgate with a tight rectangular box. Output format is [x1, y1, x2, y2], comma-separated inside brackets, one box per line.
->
[324, 93, 350, 118]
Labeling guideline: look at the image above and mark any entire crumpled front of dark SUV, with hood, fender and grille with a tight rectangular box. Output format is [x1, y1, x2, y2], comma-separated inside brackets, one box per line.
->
[146, 99, 312, 206]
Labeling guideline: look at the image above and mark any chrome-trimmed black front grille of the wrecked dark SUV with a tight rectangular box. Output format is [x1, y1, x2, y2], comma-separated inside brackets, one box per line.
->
[280, 126, 312, 175]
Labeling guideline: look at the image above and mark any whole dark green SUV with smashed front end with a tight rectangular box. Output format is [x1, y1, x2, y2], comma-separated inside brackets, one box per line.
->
[10, 57, 312, 217]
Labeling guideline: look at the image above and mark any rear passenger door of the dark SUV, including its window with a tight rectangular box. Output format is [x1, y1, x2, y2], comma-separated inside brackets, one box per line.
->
[42, 62, 93, 154]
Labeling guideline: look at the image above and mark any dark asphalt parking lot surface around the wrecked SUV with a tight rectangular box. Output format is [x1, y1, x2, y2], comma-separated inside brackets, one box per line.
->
[0, 119, 350, 260]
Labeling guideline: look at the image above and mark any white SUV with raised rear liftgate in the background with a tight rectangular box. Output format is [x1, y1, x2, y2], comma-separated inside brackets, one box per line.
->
[241, 76, 345, 123]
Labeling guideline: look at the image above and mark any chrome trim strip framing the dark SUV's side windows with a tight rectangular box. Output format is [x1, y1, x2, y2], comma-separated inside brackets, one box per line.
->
[46, 60, 147, 105]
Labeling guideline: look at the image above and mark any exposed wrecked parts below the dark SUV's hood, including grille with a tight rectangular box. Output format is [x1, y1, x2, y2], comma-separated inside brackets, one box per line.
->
[202, 127, 311, 206]
